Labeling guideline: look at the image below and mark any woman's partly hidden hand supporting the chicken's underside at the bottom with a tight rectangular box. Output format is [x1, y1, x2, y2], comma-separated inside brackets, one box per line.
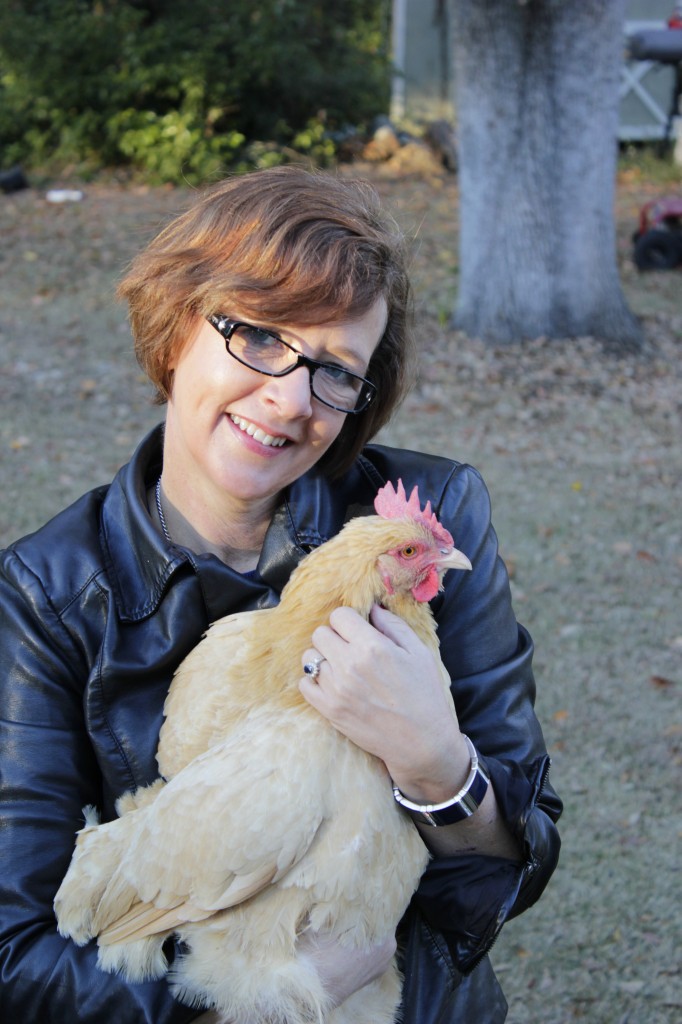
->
[297, 932, 396, 1007]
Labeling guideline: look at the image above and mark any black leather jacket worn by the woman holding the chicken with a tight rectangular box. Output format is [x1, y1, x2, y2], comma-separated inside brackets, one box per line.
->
[0, 430, 561, 1024]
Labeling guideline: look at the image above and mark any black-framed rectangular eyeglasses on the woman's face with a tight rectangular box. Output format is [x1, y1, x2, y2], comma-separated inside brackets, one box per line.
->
[206, 313, 377, 413]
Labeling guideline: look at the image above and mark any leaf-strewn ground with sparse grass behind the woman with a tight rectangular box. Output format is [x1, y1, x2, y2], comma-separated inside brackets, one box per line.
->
[0, 163, 682, 1024]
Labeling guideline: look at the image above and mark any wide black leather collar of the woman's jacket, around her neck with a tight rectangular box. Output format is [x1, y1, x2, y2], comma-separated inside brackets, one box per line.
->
[101, 425, 384, 622]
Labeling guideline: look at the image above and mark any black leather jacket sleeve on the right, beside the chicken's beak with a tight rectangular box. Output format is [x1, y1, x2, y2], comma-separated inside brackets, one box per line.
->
[405, 466, 561, 974]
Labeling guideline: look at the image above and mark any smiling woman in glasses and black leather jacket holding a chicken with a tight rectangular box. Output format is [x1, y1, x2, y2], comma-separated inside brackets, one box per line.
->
[0, 169, 560, 1024]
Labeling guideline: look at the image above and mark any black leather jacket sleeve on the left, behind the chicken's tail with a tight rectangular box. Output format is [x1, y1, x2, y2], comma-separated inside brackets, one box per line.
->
[0, 551, 201, 1024]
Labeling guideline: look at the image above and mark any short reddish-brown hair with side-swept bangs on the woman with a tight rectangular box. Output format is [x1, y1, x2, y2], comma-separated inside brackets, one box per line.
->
[118, 167, 414, 476]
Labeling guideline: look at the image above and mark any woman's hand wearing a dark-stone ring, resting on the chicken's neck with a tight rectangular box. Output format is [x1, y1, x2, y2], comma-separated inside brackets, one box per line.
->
[301, 605, 469, 803]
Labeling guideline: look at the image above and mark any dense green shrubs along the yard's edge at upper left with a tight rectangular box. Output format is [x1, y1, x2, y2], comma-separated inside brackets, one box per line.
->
[0, 0, 390, 182]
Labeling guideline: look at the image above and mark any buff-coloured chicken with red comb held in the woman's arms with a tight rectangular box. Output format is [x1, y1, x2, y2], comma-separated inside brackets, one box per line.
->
[54, 481, 471, 1024]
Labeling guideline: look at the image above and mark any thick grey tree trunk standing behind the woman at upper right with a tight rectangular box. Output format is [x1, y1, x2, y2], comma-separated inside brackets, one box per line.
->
[454, 0, 641, 347]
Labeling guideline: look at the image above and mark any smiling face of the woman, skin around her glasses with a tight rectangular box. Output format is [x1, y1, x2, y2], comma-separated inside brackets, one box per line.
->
[158, 299, 387, 516]
